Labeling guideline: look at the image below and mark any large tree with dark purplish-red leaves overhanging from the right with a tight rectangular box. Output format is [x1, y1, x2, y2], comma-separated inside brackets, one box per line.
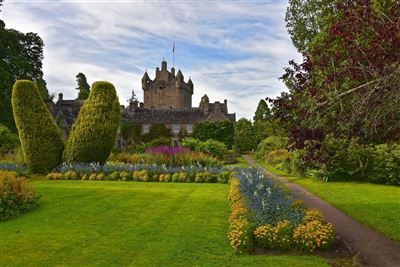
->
[270, 0, 400, 179]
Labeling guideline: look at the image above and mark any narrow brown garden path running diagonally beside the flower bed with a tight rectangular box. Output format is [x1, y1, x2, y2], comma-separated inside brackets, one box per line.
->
[243, 155, 400, 267]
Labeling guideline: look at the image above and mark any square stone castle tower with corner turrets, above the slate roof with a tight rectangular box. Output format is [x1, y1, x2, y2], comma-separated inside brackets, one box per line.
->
[142, 60, 193, 109]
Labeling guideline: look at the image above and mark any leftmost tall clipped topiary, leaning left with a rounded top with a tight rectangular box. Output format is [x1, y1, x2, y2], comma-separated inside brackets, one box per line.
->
[12, 80, 64, 173]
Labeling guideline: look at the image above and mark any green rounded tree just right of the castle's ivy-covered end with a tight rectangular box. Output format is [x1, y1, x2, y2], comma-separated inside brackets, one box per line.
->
[235, 118, 257, 152]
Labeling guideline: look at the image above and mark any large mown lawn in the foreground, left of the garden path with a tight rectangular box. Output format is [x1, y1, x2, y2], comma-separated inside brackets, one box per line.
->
[0, 180, 328, 266]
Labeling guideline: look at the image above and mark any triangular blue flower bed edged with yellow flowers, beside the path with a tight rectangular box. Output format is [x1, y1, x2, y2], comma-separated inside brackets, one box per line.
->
[228, 169, 335, 253]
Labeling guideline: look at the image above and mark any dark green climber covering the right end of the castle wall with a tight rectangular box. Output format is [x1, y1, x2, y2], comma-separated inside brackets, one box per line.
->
[192, 121, 235, 149]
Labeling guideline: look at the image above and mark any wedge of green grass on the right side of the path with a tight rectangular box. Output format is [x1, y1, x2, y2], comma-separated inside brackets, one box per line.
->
[252, 156, 400, 242]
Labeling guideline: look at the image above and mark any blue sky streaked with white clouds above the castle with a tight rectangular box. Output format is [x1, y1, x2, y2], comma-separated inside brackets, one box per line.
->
[0, 0, 301, 119]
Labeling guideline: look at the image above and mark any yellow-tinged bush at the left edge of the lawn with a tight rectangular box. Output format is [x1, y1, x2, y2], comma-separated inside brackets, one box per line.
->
[0, 171, 39, 221]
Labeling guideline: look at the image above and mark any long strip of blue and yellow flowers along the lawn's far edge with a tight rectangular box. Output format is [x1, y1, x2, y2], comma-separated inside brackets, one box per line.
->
[47, 163, 234, 183]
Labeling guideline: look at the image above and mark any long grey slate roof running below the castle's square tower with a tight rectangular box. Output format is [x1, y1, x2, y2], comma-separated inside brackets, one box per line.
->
[122, 108, 206, 124]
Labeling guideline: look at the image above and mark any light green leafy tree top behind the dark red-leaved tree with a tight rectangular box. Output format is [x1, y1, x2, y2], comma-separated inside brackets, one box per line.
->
[285, 0, 338, 52]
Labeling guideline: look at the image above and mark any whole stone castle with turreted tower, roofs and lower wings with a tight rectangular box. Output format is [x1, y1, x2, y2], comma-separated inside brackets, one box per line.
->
[47, 60, 236, 146]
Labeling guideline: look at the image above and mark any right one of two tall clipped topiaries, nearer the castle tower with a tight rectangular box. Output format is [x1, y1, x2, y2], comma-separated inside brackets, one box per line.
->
[63, 81, 121, 163]
